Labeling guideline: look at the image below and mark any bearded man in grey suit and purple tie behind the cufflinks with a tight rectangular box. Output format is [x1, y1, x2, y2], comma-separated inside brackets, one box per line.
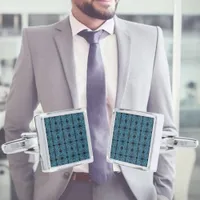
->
[5, 0, 177, 200]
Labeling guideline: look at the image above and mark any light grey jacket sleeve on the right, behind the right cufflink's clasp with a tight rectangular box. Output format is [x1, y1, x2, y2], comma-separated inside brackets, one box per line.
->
[147, 27, 177, 200]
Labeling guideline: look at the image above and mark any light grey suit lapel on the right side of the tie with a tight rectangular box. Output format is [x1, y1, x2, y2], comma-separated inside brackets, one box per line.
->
[115, 17, 131, 108]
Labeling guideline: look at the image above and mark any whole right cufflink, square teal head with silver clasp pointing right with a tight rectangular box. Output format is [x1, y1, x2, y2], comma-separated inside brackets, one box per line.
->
[107, 109, 198, 171]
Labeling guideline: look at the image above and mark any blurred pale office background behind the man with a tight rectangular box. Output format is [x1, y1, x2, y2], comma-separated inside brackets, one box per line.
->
[0, 0, 200, 200]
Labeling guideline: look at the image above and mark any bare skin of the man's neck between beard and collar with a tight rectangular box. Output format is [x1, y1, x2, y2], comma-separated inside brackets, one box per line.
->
[72, 5, 105, 30]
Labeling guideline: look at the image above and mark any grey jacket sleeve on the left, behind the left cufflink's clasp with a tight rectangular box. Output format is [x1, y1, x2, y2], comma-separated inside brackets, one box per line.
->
[4, 29, 37, 200]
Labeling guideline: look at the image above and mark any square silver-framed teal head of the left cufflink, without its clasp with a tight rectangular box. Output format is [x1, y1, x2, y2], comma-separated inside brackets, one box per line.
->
[35, 109, 93, 171]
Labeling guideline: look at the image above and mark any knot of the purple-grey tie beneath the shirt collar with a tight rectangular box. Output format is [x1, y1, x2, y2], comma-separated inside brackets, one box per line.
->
[78, 30, 103, 44]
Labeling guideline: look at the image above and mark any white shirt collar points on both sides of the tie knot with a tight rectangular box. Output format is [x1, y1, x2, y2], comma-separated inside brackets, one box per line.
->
[69, 13, 114, 36]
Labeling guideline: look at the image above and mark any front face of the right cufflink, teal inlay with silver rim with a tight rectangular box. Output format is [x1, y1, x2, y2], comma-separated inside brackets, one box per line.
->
[108, 109, 163, 170]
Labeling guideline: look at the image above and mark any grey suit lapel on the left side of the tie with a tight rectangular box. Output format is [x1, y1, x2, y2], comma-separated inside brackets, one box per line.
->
[54, 17, 78, 109]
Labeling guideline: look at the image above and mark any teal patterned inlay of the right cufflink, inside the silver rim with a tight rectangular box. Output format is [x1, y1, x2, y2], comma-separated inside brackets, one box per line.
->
[110, 112, 154, 167]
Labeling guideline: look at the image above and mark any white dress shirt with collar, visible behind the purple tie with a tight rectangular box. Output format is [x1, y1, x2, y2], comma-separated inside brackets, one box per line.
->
[69, 14, 120, 172]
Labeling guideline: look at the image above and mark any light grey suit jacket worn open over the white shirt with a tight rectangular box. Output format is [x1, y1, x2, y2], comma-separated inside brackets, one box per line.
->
[5, 17, 177, 200]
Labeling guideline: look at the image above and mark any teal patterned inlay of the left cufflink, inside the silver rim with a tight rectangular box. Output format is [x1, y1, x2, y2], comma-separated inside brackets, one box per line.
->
[44, 113, 90, 167]
